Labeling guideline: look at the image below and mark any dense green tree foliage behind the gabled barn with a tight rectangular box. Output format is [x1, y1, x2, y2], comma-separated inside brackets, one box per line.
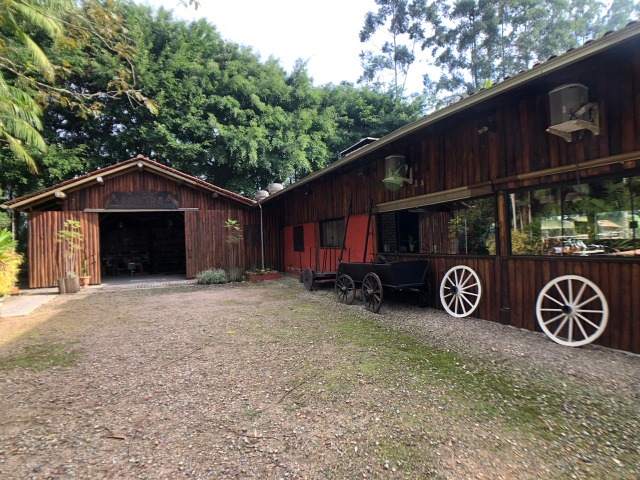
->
[0, 0, 420, 197]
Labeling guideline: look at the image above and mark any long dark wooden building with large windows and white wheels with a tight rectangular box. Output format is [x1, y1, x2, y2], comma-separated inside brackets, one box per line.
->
[261, 23, 640, 353]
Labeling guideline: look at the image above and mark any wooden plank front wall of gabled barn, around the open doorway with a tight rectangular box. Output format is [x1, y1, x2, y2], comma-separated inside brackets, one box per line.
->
[28, 169, 260, 288]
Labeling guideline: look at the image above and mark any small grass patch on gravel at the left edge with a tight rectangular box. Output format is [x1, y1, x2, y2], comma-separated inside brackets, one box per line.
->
[0, 342, 82, 372]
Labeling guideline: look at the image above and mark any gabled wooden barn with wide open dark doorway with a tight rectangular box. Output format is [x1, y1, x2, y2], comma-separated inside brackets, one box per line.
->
[6, 156, 260, 288]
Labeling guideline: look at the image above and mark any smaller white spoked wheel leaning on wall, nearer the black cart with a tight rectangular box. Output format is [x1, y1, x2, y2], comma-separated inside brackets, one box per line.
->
[440, 265, 482, 318]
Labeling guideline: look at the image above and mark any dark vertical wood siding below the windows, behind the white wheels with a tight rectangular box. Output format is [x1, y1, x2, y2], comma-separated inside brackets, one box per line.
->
[387, 255, 640, 353]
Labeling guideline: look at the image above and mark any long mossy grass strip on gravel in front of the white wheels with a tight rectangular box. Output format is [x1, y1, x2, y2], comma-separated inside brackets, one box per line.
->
[325, 315, 637, 440]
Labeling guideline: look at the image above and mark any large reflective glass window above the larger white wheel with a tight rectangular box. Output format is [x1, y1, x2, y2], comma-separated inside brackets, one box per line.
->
[509, 177, 640, 257]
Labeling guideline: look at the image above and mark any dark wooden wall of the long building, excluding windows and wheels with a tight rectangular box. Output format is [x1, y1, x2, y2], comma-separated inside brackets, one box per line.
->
[263, 38, 640, 353]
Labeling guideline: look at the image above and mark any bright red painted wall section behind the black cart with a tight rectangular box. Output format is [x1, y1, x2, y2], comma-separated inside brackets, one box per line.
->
[283, 215, 375, 274]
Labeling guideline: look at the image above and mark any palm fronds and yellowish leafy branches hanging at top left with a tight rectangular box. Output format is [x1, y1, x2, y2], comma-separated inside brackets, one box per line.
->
[0, 0, 155, 172]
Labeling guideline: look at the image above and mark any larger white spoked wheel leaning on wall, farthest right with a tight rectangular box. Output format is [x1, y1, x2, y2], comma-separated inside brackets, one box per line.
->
[536, 275, 609, 347]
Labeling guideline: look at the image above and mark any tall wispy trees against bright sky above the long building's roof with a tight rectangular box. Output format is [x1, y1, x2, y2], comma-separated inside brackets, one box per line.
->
[360, 0, 638, 108]
